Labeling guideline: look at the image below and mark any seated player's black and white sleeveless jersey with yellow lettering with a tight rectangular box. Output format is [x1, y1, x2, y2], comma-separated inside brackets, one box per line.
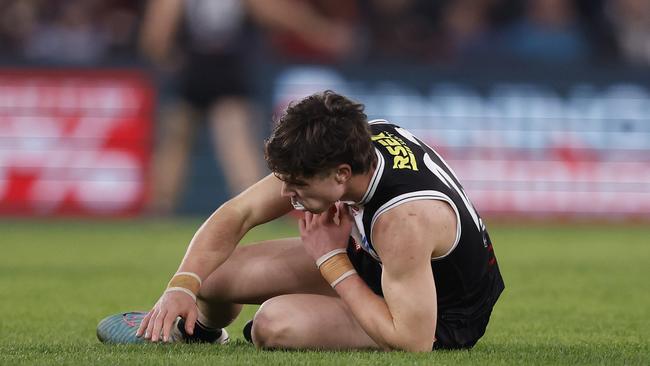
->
[350, 120, 504, 318]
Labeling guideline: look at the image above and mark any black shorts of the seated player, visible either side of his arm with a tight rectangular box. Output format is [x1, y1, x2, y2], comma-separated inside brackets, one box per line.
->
[347, 242, 492, 350]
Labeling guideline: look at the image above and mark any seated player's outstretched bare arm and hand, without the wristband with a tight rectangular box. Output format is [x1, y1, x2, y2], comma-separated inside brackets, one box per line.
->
[136, 174, 292, 342]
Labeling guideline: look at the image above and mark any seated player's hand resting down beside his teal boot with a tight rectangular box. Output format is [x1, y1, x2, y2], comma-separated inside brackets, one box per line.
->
[135, 291, 198, 342]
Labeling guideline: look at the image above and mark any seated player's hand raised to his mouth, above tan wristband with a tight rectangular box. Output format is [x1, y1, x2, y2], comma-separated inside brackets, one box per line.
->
[298, 202, 352, 260]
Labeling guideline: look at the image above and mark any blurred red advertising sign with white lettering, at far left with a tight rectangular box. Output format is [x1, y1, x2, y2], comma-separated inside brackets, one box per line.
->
[0, 70, 153, 216]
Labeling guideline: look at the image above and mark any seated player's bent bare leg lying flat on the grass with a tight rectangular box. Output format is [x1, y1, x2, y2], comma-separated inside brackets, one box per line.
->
[251, 294, 380, 350]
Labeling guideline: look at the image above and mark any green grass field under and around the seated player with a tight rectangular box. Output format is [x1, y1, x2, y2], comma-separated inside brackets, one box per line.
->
[0, 219, 650, 365]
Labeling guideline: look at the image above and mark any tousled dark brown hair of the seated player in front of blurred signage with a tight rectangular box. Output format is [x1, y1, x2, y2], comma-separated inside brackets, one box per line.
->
[264, 90, 376, 180]
